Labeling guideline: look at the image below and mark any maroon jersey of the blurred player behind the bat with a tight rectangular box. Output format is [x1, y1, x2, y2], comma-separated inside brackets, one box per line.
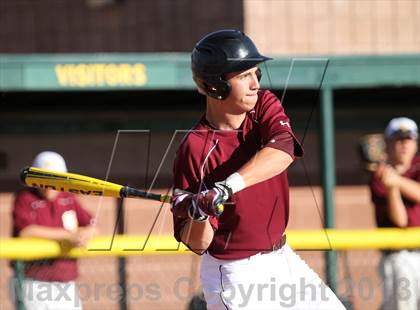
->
[13, 189, 92, 282]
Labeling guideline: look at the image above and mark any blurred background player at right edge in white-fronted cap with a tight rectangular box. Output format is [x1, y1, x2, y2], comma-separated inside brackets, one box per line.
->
[370, 117, 420, 310]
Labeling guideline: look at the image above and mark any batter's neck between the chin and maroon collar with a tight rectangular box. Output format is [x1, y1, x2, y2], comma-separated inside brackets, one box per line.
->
[206, 102, 246, 130]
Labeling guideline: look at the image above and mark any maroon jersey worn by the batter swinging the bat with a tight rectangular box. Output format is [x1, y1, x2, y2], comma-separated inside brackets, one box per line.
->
[174, 91, 303, 259]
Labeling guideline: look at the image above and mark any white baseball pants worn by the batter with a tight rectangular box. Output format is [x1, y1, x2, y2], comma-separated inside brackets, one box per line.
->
[201, 244, 345, 310]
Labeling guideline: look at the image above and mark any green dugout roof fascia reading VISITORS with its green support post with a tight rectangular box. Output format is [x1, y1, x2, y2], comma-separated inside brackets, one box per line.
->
[0, 53, 420, 287]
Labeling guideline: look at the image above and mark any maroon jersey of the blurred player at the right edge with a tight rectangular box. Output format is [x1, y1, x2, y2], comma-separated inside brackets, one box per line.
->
[370, 156, 420, 227]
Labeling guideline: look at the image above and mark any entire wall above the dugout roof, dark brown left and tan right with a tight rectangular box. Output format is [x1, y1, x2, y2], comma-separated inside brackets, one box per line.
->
[0, 0, 420, 55]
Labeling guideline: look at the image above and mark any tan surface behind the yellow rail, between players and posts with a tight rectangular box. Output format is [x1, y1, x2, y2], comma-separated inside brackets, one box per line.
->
[0, 186, 382, 310]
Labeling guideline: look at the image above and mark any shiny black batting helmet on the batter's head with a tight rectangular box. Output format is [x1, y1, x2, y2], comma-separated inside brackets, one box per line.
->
[191, 29, 271, 100]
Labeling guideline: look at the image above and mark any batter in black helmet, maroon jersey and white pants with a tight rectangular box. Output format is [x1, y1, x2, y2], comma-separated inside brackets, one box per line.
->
[172, 30, 344, 309]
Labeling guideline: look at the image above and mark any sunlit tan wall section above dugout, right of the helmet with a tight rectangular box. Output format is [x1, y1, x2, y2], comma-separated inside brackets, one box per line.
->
[244, 0, 420, 55]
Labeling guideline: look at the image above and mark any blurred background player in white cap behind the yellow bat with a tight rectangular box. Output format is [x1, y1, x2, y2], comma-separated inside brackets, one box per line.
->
[13, 151, 95, 310]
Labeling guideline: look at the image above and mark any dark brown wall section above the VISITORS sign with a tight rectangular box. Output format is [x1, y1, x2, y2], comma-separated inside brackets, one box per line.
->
[0, 0, 243, 53]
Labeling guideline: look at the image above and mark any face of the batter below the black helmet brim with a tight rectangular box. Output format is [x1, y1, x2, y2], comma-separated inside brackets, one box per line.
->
[226, 67, 260, 112]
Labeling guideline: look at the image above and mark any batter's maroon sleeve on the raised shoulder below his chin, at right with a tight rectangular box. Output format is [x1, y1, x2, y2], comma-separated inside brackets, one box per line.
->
[257, 91, 303, 158]
